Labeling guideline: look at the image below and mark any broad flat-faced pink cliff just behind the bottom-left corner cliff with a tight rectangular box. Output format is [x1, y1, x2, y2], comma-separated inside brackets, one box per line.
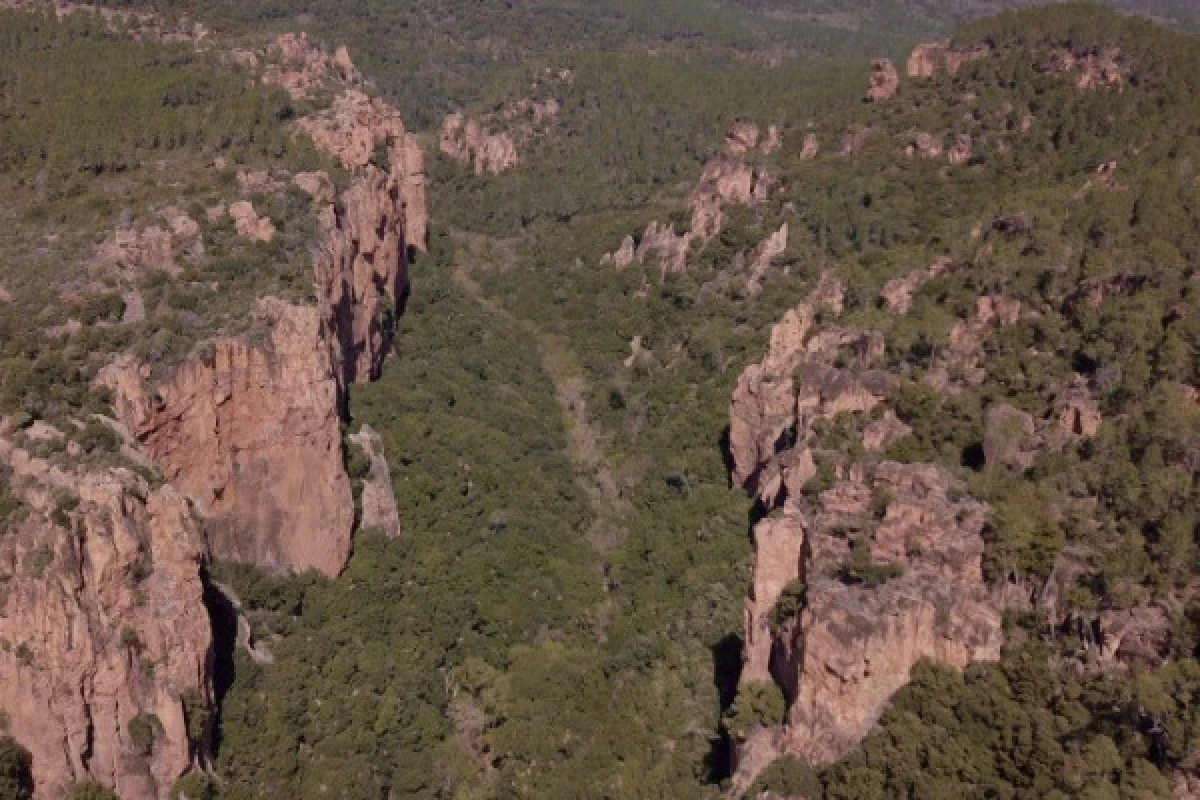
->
[101, 299, 354, 576]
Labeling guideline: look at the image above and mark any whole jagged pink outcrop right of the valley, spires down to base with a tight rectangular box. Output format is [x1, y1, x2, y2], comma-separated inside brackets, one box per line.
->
[730, 277, 1002, 796]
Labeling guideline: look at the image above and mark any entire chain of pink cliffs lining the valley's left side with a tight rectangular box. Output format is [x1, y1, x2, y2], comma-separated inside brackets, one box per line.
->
[0, 9, 427, 800]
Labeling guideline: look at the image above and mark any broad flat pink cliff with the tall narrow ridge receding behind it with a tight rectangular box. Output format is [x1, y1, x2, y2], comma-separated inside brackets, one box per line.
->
[103, 45, 427, 576]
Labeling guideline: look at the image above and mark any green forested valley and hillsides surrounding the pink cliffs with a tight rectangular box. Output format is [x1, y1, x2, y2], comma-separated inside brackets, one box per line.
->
[0, 0, 1200, 800]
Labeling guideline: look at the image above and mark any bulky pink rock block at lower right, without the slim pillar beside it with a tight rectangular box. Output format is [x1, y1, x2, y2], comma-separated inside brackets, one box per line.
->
[780, 462, 1002, 764]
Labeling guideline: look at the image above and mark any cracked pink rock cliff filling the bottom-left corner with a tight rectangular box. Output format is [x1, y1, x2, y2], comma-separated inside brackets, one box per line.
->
[0, 439, 212, 800]
